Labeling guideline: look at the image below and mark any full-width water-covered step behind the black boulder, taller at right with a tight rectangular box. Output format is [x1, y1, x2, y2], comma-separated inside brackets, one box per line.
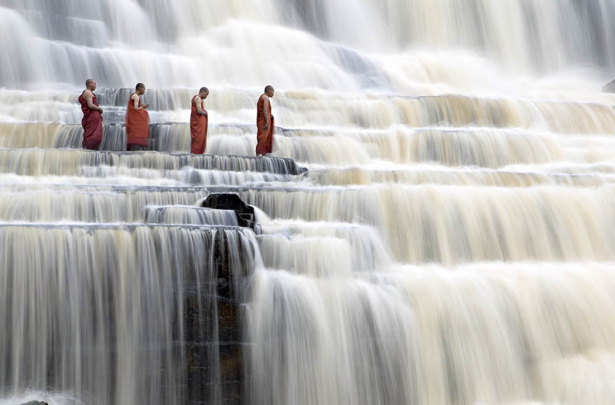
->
[0, 184, 615, 265]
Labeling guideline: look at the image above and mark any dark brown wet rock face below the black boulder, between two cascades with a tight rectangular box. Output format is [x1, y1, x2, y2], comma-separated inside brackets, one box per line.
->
[178, 232, 254, 405]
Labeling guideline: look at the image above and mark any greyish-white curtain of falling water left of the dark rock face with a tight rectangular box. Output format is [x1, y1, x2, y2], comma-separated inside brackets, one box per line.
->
[0, 224, 258, 404]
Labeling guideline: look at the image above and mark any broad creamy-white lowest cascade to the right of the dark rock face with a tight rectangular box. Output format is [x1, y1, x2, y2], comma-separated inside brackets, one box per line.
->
[248, 263, 615, 405]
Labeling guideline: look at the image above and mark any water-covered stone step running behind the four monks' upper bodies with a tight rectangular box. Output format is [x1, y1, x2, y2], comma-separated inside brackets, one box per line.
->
[2, 89, 615, 134]
